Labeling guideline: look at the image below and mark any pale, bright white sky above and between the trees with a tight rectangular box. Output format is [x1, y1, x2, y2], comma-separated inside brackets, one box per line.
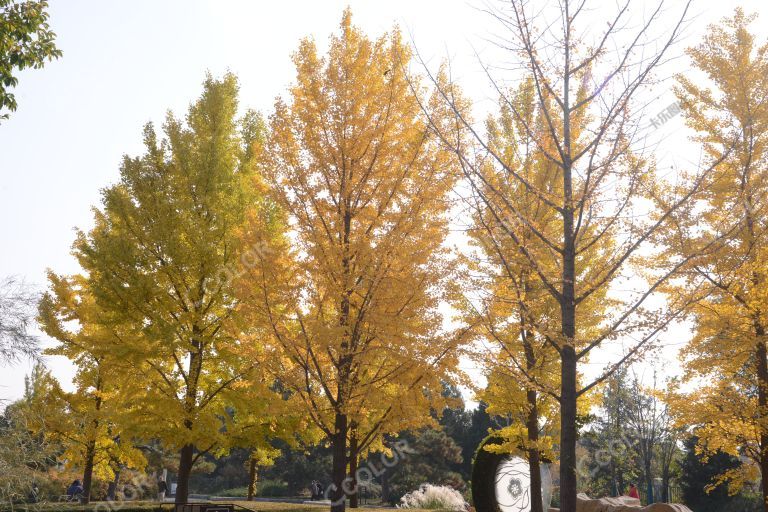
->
[0, 0, 768, 399]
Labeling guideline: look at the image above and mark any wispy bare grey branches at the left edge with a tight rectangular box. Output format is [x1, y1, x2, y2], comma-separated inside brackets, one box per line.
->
[0, 276, 39, 365]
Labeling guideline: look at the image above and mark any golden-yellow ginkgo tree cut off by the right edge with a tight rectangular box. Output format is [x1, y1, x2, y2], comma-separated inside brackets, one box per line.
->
[669, 9, 768, 510]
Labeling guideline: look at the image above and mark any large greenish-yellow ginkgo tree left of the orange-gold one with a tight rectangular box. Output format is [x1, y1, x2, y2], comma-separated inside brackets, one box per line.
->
[64, 74, 288, 503]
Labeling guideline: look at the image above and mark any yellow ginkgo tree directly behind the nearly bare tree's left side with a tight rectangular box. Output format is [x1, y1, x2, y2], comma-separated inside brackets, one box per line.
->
[457, 81, 559, 512]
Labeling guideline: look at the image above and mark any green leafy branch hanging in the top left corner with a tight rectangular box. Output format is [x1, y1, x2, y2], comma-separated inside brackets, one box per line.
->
[0, 0, 61, 120]
